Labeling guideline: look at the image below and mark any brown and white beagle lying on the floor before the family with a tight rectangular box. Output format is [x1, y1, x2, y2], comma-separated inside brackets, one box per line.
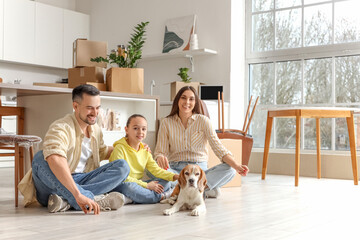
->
[161, 164, 207, 216]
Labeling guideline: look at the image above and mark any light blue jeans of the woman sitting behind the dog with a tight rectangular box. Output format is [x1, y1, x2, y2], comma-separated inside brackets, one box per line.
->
[168, 161, 236, 190]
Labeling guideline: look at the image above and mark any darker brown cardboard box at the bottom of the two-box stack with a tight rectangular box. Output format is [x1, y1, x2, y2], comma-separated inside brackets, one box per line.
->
[68, 67, 104, 88]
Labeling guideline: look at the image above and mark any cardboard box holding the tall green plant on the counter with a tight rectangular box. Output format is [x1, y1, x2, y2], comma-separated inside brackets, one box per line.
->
[106, 67, 144, 94]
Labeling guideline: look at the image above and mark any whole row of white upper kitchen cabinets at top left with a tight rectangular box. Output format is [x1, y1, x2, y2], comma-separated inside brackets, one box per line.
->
[0, 0, 90, 68]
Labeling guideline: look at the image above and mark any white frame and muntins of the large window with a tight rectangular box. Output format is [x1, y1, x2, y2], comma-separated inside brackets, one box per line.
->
[245, 0, 360, 151]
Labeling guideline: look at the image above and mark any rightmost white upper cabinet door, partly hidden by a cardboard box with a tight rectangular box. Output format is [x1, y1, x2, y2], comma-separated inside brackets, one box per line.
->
[63, 9, 90, 68]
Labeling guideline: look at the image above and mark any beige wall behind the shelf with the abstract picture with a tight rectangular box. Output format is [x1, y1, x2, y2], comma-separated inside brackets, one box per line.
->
[76, 0, 235, 101]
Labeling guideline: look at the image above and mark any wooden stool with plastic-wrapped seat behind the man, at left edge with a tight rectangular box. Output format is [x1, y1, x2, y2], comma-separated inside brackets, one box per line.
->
[0, 134, 42, 207]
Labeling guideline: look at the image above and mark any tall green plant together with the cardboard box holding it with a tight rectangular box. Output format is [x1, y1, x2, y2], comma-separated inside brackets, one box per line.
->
[91, 22, 149, 94]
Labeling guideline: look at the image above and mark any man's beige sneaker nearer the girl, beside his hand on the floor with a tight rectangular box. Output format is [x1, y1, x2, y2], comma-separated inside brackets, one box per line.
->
[94, 192, 125, 211]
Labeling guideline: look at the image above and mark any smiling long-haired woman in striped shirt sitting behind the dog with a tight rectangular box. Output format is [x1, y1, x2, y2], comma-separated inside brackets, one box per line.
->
[154, 86, 249, 197]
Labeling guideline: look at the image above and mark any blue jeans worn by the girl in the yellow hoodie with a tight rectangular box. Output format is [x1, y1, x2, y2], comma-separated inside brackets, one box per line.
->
[114, 178, 171, 204]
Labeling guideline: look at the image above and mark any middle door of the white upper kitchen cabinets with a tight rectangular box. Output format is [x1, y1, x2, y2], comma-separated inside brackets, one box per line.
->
[35, 2, 63, 67]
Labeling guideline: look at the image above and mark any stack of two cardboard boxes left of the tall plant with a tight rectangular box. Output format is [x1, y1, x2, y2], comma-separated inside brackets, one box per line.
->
[68, 39, 107, 91]
